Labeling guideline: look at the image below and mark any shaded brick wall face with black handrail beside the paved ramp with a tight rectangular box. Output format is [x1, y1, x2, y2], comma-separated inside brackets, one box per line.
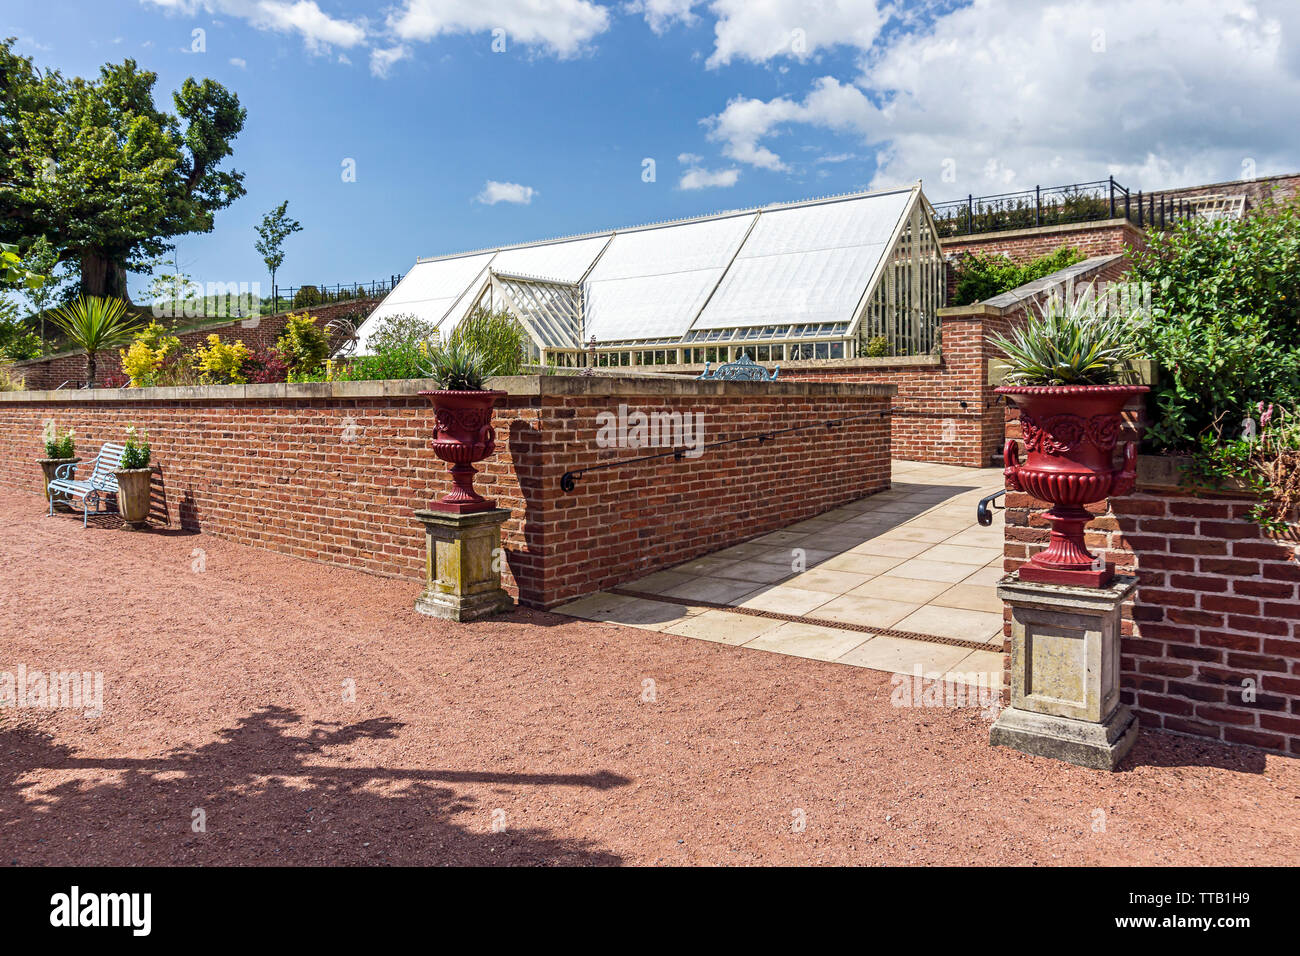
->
[543, 385, 889, 600]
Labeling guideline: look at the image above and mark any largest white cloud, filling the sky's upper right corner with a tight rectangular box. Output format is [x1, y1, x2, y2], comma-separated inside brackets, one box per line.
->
[703, 0, 1300, 199]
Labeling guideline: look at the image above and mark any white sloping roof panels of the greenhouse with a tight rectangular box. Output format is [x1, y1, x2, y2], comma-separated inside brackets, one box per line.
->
[360, 186, 920, 352]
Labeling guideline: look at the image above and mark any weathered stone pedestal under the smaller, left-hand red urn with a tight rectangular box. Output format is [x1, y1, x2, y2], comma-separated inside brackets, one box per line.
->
[415, 507, 514, 620]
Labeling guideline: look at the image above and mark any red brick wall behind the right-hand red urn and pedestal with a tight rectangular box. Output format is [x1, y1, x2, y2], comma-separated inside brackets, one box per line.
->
[1005, 416, 1300, 754]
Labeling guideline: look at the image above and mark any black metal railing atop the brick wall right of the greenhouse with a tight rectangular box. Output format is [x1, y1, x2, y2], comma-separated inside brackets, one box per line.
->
[933, 176, 1193, 237]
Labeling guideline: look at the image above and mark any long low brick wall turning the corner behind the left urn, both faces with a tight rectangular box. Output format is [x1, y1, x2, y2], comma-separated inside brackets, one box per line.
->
[0, 378, 889, 606]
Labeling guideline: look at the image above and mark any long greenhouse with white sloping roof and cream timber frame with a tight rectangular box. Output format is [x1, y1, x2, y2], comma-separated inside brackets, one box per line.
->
[359, 183, 945, 367]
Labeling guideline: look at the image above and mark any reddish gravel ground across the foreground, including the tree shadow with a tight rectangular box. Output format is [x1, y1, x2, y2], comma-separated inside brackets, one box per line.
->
[0, 494, 1300, 865]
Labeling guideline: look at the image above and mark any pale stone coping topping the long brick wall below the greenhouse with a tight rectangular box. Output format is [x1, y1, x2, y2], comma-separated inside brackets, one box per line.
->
[0, 375, 898, 405]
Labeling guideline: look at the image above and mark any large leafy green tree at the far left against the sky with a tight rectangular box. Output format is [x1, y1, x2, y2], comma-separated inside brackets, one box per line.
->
[0, 38, 244, 299]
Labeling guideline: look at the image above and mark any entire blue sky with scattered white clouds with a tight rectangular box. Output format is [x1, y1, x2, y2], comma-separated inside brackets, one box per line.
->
[4, 0, 1300, 299]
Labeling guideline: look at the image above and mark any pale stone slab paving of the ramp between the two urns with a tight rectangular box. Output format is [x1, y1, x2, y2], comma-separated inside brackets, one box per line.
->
[555, 460, 1002, 685]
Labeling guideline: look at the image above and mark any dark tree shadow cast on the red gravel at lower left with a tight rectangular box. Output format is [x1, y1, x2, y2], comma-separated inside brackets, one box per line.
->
[0, 708, 631, 866]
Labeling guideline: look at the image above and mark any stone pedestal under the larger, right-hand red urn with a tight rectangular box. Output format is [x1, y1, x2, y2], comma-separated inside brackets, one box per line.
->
[989, 575, 1138, 770]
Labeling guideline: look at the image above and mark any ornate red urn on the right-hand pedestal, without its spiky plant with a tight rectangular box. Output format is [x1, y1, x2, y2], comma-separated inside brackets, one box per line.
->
[997, 385, 1148, 588]
